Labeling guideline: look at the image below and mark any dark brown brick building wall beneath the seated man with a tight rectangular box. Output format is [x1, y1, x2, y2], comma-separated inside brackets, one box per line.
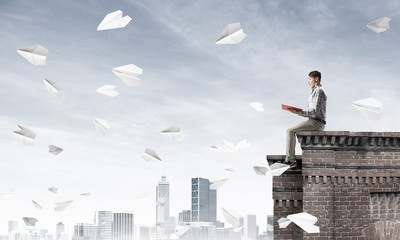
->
[267, 131, 400, 240]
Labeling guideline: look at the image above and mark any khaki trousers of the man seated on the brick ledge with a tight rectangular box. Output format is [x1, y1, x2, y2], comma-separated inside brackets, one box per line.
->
[286, 119, 325, 162]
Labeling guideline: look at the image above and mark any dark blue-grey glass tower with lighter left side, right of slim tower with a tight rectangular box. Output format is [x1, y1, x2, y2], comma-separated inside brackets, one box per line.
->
[192, 178, 217, 225]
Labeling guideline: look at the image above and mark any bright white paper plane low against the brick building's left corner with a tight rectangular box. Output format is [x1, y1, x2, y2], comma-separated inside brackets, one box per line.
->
[278, 212, 319, 233]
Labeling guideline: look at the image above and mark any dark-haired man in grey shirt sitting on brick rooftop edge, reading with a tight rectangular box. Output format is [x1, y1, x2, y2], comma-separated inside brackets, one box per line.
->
[282, 71, 327, 168]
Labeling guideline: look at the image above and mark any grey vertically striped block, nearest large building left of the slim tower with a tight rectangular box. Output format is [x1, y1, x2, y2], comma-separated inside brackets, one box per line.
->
[112, 213, 135, 240]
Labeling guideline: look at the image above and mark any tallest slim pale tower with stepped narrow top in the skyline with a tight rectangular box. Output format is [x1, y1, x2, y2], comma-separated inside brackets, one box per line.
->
[156, 176, 169, 237]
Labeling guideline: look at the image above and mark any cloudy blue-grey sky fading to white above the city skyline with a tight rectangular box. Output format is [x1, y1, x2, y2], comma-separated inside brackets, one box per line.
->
[0, 0, 400, 234]
